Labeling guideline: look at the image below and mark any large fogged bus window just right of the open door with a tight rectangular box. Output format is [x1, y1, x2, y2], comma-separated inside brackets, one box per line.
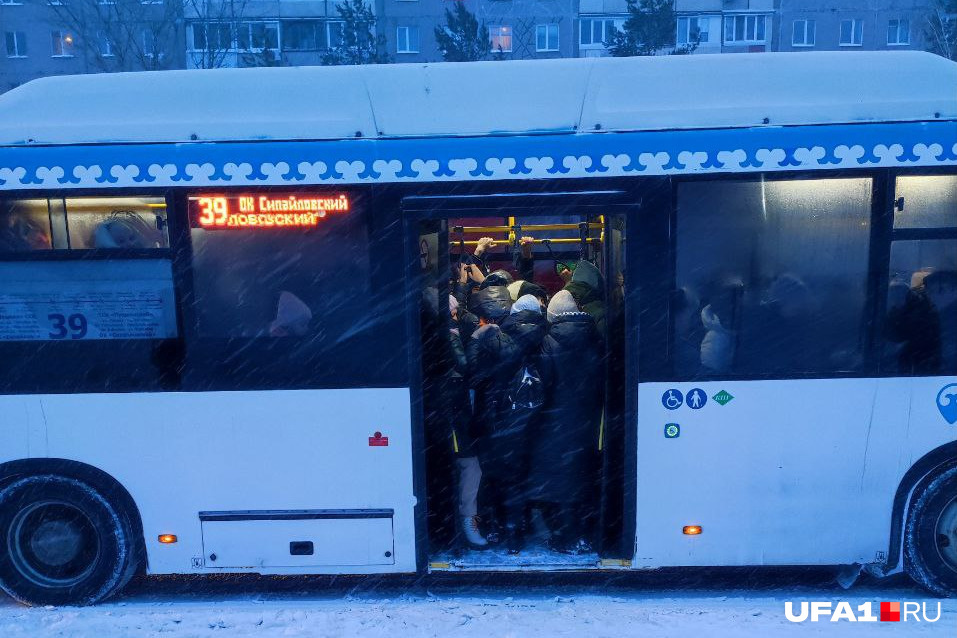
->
[672, 179, 871, 378]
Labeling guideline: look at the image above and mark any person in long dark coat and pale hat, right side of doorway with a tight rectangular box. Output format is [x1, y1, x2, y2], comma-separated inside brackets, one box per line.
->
[528, 290, 604, 552]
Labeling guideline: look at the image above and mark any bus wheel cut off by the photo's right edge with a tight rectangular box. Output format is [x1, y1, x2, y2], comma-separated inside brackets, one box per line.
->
[904, 467, 957, 596]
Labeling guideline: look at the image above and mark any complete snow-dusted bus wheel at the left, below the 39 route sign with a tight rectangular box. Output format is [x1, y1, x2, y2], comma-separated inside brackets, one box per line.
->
[0, 475, 136, 605]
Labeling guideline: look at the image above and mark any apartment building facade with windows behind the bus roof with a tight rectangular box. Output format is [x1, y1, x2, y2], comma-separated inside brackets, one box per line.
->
[0, 0, 933, 92]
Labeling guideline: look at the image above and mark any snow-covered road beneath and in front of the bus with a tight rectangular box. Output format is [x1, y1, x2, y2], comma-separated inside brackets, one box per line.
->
[0, 572, 957, 638]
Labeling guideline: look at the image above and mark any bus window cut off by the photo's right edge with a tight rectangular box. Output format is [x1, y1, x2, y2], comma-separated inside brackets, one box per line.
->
[881, 175, 957, 375]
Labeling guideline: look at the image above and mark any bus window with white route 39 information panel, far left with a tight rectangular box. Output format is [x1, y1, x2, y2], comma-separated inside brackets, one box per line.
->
[0, 197, 179, 392]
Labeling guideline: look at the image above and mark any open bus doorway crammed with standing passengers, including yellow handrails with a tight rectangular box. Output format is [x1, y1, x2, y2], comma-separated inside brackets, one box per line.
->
[418, 207, 630, 570]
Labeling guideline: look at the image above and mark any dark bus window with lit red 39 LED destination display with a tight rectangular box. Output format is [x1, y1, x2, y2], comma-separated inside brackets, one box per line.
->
[189, 192, 405, 388]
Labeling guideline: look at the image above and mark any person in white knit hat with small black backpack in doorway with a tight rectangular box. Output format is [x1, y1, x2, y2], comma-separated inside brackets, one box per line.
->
[481, 295, 546, 553]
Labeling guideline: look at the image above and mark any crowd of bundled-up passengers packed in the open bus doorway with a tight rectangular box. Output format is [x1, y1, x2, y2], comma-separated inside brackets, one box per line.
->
[424, 237, 604, 554]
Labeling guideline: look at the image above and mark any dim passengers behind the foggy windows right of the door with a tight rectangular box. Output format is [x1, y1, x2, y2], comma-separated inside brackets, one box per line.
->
[672, 268, 957, 379]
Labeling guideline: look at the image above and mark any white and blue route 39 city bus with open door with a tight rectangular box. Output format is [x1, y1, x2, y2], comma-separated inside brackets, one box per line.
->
[0, 52, 957, 604]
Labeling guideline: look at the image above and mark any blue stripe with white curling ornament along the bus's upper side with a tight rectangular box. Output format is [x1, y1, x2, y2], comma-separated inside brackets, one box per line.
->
[0, 121, 957, 190]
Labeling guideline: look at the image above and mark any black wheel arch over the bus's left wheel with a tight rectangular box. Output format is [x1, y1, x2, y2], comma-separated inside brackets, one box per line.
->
[0, 458, 147, 574]
